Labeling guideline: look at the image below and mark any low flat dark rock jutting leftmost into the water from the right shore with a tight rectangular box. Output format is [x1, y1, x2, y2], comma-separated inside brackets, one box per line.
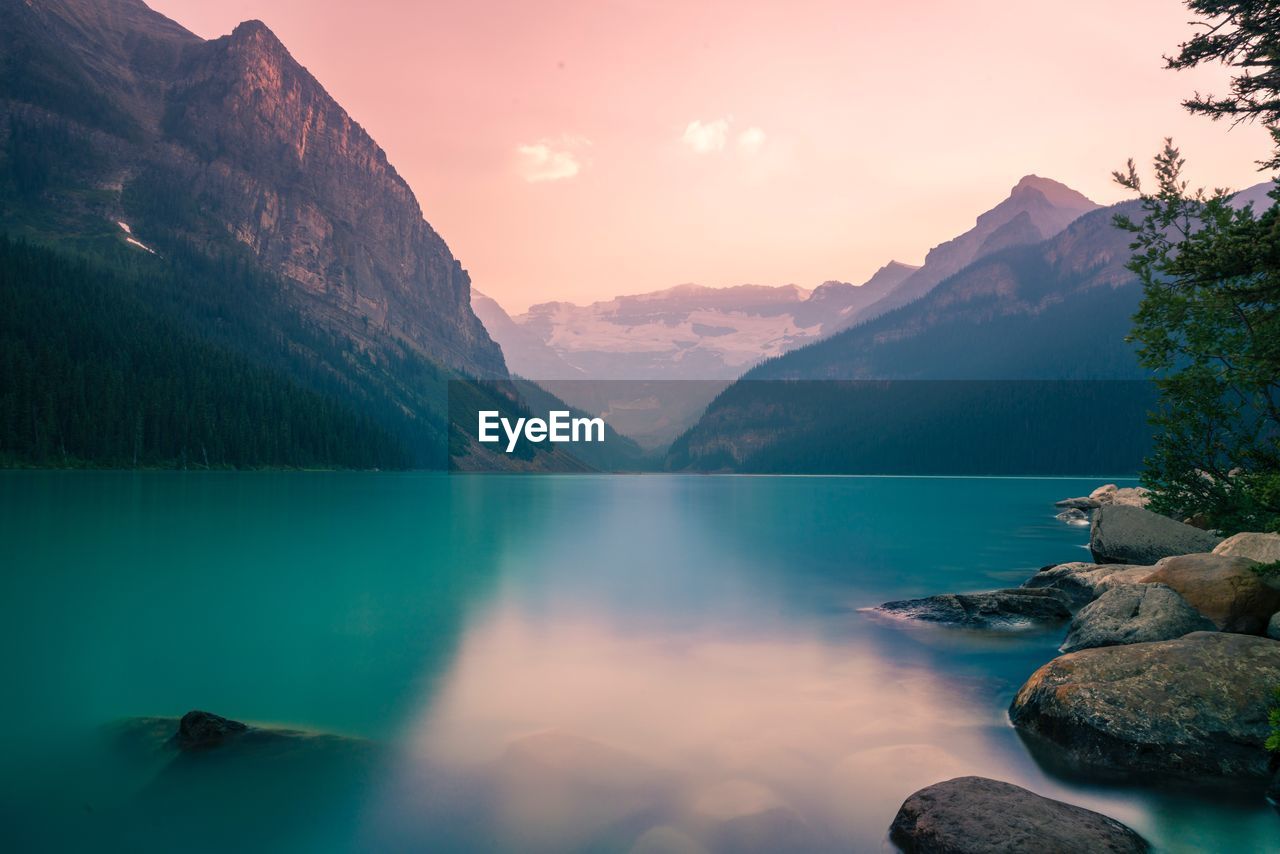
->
[876, 588, 1071, 629]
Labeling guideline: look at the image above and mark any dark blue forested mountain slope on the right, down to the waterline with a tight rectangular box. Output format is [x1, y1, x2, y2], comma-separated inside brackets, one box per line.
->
[667, 184, 1271, 474]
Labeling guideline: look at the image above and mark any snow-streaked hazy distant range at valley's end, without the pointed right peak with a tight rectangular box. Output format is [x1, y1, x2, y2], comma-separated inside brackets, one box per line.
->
[472, 261, 915, 380]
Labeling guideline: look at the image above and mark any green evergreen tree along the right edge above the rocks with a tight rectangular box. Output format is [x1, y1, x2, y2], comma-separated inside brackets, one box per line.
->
[1115, 0, 1280, 533]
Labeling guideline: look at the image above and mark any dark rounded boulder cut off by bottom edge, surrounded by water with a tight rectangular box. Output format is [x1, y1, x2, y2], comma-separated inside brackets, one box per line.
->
[888, 777, 1149, 854]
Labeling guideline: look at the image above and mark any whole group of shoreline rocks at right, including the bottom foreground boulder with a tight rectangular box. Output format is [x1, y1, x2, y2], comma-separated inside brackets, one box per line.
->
[873, 484, 1280, 851]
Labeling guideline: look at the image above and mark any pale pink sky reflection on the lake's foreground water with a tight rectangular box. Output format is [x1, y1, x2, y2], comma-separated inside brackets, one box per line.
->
[371, 609, 1004, 851]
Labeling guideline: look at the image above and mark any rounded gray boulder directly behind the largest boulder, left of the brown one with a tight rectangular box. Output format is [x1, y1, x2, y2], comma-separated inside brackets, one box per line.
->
[1062, 584, 1217, 653]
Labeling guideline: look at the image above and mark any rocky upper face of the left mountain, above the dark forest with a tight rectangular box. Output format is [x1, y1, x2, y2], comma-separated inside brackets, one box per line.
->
[0, 0, 504, 375]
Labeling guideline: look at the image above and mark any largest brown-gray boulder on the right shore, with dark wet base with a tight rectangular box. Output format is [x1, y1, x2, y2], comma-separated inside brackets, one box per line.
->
[1009, 631, 1280, 782]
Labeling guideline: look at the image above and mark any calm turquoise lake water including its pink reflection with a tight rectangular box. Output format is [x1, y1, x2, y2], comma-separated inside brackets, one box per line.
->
[0, 472, 1280, 851]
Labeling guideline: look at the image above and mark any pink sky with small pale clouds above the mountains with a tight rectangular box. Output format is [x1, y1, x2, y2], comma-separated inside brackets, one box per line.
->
[151, 0, 1268, 311]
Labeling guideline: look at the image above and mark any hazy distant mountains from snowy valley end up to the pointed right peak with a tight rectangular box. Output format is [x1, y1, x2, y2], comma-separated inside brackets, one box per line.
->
[477, 175, 1098, 380]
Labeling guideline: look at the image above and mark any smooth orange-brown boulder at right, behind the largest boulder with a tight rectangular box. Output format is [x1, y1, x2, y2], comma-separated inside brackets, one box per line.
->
[1146, 554, 1280, 635]
